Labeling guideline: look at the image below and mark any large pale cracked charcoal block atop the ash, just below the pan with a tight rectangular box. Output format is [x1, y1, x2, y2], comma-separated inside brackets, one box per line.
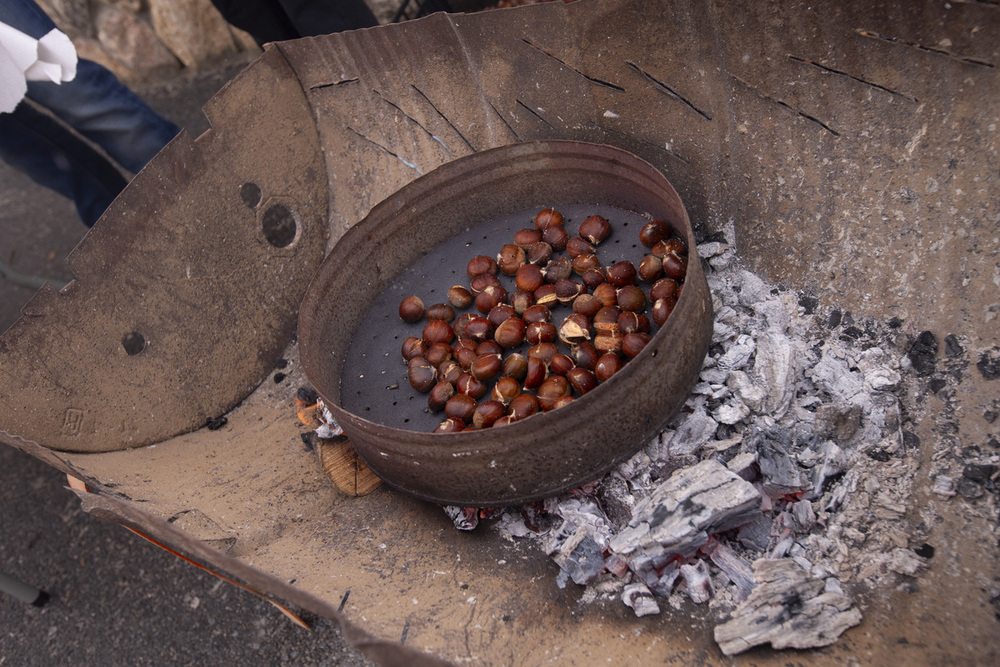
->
[611, 459, 760, 563]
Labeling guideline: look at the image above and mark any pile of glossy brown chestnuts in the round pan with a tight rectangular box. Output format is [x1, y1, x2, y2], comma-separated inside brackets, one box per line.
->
[399, 208, 688, 433]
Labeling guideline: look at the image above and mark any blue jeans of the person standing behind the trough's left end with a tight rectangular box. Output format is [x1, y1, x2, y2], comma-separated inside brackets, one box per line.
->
[0, 0, 179, 225]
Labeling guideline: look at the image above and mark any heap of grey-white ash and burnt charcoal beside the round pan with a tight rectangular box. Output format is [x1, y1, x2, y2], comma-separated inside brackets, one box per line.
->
[476, 225, 928, 652]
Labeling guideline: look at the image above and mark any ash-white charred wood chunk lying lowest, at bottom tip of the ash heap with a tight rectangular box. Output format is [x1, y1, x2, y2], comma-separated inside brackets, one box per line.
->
[714, 559, 861, 655]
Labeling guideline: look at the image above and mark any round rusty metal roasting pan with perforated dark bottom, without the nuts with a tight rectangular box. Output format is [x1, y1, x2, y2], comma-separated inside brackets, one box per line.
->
[299, 141, 712, 507]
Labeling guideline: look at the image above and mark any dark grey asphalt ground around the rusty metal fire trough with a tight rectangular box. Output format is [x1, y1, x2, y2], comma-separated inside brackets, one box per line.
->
[0, 53, 370, 667]
